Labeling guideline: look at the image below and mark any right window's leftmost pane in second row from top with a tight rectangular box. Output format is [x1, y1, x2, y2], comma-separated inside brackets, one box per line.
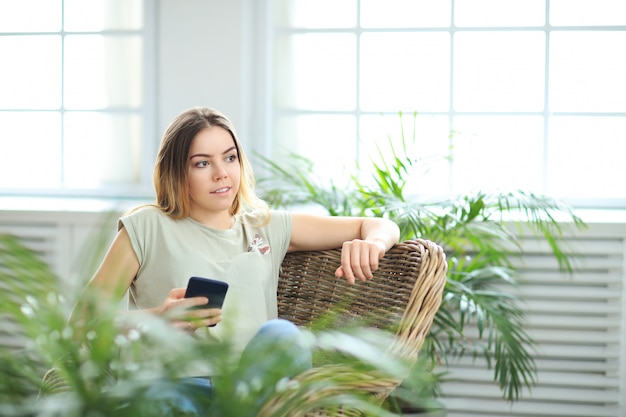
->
[274, 34, 356, 110]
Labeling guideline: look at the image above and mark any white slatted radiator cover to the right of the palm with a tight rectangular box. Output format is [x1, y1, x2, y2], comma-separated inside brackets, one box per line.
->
[443, 224, 626, 417]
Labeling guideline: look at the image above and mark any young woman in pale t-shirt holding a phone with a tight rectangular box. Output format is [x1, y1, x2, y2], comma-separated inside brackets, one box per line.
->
[79, 108, 399, 412]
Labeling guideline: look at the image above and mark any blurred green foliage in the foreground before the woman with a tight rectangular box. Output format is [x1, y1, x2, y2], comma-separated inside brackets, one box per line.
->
[0, 235, 428, 417]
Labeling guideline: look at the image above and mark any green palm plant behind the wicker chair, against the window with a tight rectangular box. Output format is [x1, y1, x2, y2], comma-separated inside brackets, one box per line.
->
[259, 113, 584, 401]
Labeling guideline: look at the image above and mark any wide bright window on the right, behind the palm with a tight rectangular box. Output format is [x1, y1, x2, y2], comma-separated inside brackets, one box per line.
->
[272, 0, 626, 207]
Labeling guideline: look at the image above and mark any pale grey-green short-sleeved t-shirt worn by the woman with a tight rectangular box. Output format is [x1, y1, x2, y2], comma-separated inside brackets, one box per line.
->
[119, 207, 291, 358]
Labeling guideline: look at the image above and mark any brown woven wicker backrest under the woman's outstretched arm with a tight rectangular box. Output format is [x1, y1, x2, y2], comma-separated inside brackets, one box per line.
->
[278, 239, 447, 361]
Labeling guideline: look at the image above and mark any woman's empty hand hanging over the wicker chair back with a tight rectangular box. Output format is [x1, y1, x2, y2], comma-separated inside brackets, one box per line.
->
[335, 239, 386, 284]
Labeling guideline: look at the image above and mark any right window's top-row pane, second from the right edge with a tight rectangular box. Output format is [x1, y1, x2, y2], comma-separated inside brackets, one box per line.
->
[454, 0, 546, 27]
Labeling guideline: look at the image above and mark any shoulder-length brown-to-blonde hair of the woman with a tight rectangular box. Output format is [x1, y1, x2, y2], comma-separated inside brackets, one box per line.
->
[144, 107, 269, 222]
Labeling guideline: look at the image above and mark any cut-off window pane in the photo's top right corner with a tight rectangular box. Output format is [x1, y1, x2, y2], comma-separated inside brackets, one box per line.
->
[550, 0, 626, 26]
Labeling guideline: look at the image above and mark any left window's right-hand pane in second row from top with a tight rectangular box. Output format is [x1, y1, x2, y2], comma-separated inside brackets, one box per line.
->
[64, 35, 142, 109]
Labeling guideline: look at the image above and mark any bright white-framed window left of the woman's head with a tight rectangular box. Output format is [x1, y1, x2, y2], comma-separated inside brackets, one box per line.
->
[0, 0, 153, 195]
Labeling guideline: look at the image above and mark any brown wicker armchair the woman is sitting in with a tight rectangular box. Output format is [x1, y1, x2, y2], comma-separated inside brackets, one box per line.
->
[259, 239, 447, 417]
